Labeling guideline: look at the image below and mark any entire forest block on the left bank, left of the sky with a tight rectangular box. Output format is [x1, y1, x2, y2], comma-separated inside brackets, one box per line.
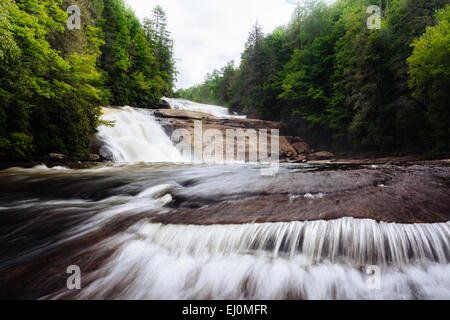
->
[0, 0, 176, 160]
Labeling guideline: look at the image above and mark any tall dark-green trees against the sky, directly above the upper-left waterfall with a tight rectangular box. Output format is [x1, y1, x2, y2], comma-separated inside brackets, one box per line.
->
[100, 0, 176, 108]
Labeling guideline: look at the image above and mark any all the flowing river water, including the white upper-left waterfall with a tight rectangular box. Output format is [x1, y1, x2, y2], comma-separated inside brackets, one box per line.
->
[0, 103, 450, 299]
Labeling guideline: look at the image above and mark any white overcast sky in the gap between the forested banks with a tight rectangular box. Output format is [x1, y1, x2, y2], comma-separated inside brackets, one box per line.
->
[126, 0, 297, 88]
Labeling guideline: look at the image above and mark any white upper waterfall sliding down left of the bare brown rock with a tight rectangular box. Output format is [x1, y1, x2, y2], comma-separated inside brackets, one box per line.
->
[97, 107, 186, 163]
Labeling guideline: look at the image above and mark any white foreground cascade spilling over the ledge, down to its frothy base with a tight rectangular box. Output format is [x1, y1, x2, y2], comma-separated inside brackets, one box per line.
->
[49, 218, 450, 299]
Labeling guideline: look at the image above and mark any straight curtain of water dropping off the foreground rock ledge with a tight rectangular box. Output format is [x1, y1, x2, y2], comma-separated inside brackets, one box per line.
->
[138, 218, 450, 266]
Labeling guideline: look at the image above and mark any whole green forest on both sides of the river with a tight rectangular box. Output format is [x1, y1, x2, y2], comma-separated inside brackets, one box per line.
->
[0, 0, 450, 160]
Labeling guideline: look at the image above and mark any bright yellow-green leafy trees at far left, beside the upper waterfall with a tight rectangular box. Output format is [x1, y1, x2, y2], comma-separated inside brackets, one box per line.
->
[0, 0, 101, 159]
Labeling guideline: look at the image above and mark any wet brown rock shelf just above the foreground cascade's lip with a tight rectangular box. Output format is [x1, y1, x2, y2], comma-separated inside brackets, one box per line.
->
[156, 166, 450, 224]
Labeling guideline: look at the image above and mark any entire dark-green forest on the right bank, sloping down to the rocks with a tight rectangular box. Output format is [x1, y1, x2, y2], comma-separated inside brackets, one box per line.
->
[176, 0, 450, 155]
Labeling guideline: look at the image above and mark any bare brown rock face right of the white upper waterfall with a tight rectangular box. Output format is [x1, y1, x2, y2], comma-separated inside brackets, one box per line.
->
[149, 109, 311, 162]
